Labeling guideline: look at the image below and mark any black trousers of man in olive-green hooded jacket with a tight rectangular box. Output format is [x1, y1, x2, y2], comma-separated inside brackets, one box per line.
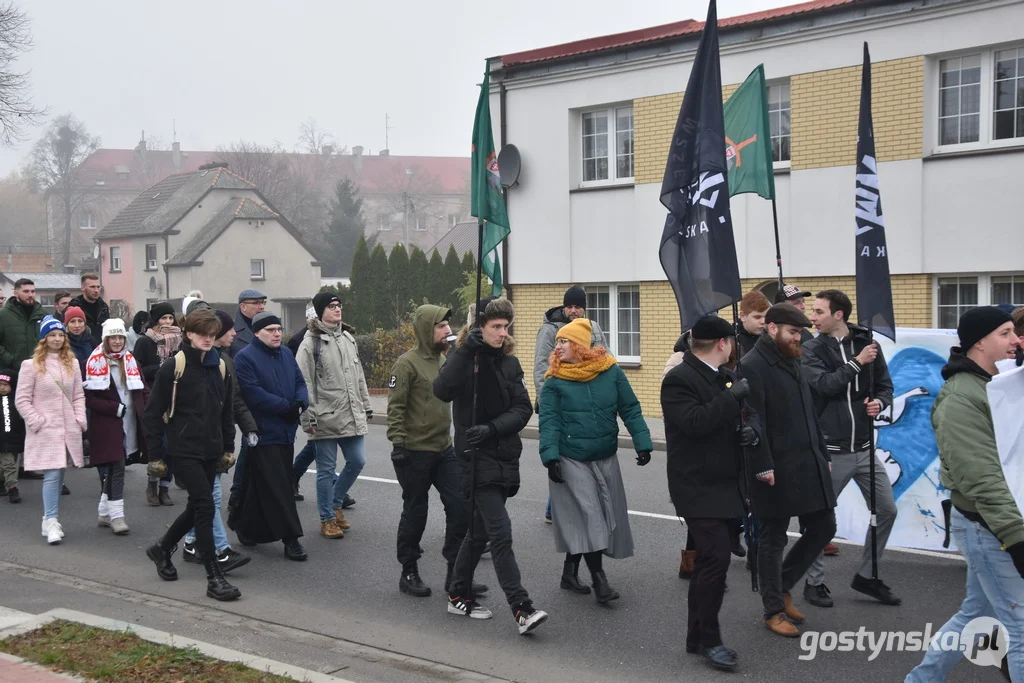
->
[392, 447, 469, 571]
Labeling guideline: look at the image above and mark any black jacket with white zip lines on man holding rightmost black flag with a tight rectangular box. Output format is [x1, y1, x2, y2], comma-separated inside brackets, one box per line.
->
[803, 325, 893, 454]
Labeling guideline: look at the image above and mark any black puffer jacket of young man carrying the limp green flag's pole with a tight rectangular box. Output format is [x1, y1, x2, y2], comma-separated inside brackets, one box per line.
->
[434, 329, 534, 498]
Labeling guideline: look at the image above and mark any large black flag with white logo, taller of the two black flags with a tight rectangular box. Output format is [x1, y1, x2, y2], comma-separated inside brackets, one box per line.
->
[658, 0, 742, 332]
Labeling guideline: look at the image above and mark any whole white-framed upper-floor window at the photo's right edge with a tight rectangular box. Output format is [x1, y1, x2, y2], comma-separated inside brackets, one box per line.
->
[935, 46, 1024, 151]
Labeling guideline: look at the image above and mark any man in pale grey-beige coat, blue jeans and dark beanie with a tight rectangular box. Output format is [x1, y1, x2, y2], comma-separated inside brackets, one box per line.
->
[296, 292, 373, 539]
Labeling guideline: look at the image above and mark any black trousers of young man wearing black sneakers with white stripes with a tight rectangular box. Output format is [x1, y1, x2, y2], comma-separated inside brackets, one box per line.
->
[451, 486, 529, 608]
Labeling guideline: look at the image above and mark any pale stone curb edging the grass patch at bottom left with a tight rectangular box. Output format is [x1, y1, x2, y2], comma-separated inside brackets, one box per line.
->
[0, 608, 353, 683]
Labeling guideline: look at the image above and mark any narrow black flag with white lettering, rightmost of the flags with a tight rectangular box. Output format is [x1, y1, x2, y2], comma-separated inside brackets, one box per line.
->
[855, 43, 896, 341]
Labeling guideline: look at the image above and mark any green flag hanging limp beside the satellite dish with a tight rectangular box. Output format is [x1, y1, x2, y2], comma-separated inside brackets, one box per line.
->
[470, 66, 511, 296]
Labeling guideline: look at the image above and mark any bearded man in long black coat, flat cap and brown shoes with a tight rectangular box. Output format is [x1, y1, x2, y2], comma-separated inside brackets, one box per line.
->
[741, 303, 836, 638]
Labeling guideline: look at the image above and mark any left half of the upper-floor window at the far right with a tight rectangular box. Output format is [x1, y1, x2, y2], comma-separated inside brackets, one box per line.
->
[939, 54, 981, 144]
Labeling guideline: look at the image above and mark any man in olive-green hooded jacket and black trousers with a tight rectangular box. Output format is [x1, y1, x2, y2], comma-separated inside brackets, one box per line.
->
[387, 304, 487, 598]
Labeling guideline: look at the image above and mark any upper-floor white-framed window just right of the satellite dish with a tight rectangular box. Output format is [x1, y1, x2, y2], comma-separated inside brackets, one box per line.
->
[581, 105, 633, 183]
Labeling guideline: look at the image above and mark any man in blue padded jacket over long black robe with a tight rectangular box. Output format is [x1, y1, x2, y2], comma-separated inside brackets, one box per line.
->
[232, 311, 309, 562]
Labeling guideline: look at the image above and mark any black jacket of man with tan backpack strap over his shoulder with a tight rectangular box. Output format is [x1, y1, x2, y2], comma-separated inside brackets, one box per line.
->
[142, 344, 234, 460]
